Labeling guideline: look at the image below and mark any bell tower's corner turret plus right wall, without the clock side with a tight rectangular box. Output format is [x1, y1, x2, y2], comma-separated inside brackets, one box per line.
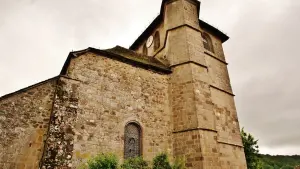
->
[162, 0, 246, 169]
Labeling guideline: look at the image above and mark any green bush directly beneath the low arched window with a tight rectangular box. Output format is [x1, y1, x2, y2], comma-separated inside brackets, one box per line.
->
[121, 157, 149, 169]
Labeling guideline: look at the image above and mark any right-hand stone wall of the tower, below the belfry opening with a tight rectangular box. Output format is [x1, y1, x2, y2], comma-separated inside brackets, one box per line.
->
[205, 31, 246, 169]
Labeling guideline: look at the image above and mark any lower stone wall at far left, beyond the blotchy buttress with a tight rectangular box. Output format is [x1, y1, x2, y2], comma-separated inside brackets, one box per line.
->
[0, 79, 56, 169]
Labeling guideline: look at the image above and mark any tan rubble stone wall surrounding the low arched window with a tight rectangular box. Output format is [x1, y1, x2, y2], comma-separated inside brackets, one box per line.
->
[68, 53, 172, 166]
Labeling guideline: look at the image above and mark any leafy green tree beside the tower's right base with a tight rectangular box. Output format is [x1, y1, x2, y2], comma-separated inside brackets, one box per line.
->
[241, 128, 262, 169]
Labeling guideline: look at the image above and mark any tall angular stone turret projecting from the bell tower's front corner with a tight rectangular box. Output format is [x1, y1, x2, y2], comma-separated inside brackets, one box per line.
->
[164, 0, 220, 169]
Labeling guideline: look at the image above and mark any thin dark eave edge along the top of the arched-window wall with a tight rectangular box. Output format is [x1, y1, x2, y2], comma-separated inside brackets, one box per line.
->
[60, 47, 172, 75]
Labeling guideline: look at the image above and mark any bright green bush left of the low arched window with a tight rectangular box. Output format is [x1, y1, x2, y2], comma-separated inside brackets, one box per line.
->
[88, 154, 118, 169]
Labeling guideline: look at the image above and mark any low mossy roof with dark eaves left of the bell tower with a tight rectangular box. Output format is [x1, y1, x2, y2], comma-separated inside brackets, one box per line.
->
[60, 46, 171, 75]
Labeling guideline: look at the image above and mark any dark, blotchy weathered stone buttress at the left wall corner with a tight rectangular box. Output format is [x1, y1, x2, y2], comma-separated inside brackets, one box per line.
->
[41, 77, 78, 168]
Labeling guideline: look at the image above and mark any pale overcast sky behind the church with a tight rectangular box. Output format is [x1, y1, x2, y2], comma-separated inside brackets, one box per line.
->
[0, 0, 300, 155]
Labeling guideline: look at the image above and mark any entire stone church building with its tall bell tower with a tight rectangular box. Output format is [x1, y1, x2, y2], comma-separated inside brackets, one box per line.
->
[0, 0, 247, 169]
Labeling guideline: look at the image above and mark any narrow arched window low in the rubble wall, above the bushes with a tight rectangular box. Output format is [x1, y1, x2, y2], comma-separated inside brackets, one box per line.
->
[124, 123, 141, 159]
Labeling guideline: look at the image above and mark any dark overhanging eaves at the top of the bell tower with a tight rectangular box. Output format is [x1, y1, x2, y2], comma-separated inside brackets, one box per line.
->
[129, 0, 229, 50]
